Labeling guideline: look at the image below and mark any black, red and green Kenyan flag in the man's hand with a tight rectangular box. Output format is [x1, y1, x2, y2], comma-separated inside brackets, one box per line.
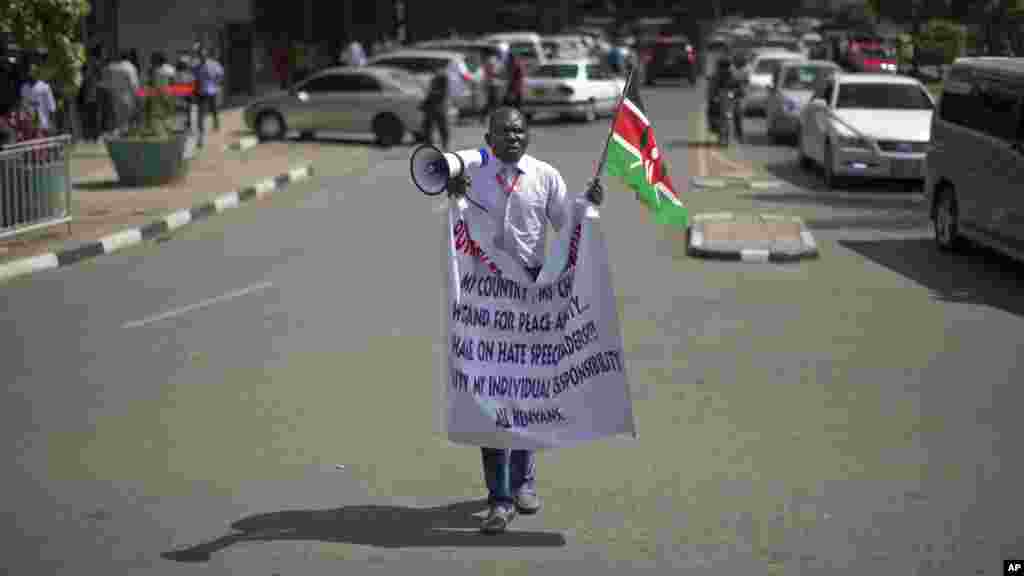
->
[605, 75, 689, 229]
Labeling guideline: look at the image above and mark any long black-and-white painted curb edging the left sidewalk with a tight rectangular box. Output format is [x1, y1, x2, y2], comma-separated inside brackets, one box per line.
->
[0, 164, 313, 282]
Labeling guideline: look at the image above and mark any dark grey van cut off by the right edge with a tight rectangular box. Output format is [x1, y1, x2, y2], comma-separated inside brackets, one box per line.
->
[925, 57, 1024, 255]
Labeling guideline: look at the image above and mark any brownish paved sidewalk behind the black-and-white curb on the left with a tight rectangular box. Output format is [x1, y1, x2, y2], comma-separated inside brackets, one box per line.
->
[0, 108, 369, 263]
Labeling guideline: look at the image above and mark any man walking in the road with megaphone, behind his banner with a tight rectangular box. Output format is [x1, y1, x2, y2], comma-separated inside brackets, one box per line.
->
[449, 107, 604, 533]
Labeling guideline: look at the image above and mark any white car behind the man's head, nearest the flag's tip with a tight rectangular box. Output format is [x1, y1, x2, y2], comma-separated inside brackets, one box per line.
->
[522, 58, 626, 122]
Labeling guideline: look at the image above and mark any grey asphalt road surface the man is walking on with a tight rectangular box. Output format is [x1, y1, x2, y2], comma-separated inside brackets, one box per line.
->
[0, 86, 1024, 576]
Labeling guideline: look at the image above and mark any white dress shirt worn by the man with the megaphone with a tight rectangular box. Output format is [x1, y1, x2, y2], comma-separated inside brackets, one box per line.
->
[470, 154, 571, 269]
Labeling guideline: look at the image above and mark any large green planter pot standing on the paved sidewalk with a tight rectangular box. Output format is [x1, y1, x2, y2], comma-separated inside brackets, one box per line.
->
[105, 132, 188, 186]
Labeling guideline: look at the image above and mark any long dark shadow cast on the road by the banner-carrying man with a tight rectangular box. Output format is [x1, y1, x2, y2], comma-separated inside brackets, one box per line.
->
[161, 500, 565, 563]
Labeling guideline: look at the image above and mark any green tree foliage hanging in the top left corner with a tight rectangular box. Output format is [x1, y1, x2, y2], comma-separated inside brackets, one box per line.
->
[0, 0, 90, 132]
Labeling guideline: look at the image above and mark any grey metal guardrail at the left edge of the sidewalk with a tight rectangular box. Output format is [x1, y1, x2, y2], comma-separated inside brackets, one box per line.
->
[0, 134, 72, 239]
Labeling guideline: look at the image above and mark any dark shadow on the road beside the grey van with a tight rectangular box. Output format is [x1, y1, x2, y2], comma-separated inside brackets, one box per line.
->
[840, 239, 1024, 316]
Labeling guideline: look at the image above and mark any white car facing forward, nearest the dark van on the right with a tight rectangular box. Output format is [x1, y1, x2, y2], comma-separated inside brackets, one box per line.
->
[799, 74, 935, 188]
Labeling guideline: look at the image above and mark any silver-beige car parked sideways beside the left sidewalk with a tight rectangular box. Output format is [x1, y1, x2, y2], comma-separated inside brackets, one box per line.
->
[244, 67, 426, 146]
